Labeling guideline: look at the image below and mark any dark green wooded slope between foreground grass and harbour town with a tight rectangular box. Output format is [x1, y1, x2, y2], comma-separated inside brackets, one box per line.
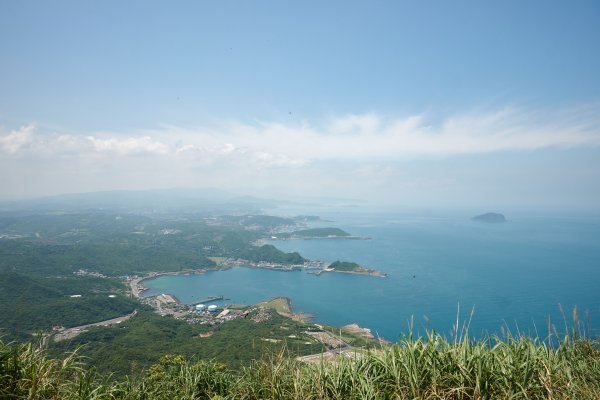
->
[50, 310, 324, 376]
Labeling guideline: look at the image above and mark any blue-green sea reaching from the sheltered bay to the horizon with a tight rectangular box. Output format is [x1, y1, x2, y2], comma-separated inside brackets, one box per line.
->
[145, 213, 600, 341]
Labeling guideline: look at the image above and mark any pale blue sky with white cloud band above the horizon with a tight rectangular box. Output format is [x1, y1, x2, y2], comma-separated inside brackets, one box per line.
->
[0, 0, 600, 212]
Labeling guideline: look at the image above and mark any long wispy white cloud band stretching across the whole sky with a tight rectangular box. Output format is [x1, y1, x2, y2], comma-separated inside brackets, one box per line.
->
[0, 109, 600, 162]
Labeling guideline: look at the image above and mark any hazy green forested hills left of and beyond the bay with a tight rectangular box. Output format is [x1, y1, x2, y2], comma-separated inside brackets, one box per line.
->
[0, 211, 304, 341]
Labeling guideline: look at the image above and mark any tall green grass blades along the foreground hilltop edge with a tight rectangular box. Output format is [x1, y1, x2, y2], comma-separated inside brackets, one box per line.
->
[0, 332, 600, 400]
